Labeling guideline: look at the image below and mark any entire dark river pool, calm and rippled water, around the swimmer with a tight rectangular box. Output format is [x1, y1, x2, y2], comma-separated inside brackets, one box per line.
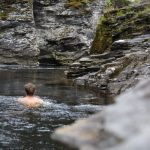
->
[0, 66, 104, 150]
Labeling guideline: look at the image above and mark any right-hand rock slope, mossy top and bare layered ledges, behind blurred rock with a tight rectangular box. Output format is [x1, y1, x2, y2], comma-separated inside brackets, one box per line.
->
[67, 3, 150, 95]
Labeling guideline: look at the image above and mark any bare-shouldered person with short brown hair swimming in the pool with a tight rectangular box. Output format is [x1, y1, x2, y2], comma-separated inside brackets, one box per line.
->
[17, 83, 43, 108]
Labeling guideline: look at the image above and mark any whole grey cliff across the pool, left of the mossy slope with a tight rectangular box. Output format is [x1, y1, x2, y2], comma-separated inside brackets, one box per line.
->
[0, 0, 104, 65]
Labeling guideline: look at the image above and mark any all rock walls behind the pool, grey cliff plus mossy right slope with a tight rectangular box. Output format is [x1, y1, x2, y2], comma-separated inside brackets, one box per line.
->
[0, 0, 150, 95]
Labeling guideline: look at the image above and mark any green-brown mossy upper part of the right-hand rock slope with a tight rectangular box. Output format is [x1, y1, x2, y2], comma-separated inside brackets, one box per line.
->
[90, 4, 150, 53]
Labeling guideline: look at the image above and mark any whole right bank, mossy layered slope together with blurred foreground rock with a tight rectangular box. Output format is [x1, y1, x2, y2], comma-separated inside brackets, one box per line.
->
[52, 3, 150, 150]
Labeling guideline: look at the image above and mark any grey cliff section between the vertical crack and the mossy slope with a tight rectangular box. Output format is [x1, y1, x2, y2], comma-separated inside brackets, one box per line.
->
[33, 0, 104, 64]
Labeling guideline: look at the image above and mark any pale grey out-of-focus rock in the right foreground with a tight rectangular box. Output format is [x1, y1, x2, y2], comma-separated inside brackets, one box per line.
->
[53, 80, 150, 150]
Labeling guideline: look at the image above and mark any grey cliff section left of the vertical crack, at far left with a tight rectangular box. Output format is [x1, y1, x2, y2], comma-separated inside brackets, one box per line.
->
[0, 0, 39, 65]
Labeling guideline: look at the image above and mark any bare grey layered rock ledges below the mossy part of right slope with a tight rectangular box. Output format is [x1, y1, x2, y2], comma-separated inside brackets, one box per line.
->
[68, 34, 150, 95]
